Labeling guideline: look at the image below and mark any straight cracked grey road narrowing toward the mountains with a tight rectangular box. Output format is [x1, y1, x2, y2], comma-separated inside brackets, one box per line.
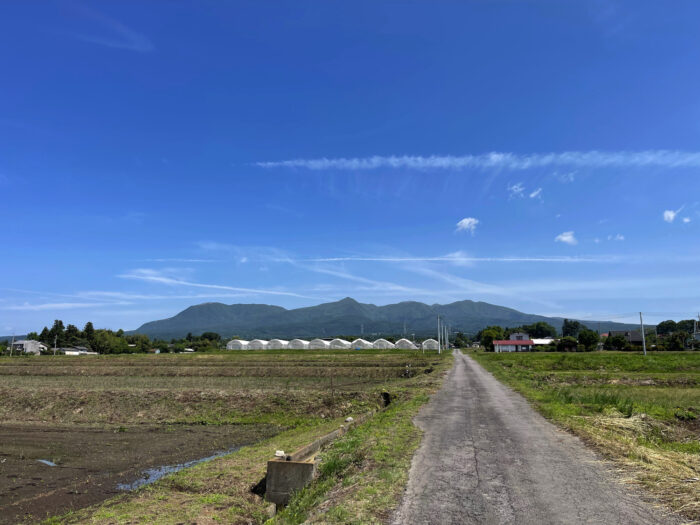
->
[394, 354, 680, 525]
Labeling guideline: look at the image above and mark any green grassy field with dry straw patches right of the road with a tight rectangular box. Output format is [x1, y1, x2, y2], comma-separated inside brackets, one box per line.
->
[470, 352, 700, 520]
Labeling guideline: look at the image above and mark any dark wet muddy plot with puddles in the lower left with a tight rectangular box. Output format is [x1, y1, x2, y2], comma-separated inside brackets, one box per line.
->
[0, 424, 280, 524]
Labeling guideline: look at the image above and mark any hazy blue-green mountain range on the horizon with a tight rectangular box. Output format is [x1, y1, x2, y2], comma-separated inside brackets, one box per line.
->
[127, 297, 636, 340]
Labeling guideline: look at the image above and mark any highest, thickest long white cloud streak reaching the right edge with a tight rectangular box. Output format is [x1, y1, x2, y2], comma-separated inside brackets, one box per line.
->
[255, 150, 700, 171]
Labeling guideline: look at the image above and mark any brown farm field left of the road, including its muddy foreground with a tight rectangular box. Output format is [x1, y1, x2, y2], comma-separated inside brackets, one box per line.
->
[0, 350, 440, 523]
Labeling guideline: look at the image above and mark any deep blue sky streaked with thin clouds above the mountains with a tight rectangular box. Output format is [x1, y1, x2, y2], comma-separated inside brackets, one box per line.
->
[0, 0, 700, 333]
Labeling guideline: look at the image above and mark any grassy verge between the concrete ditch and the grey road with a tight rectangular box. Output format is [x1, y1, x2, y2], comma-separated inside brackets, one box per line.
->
[271, 350, 452, 524]
